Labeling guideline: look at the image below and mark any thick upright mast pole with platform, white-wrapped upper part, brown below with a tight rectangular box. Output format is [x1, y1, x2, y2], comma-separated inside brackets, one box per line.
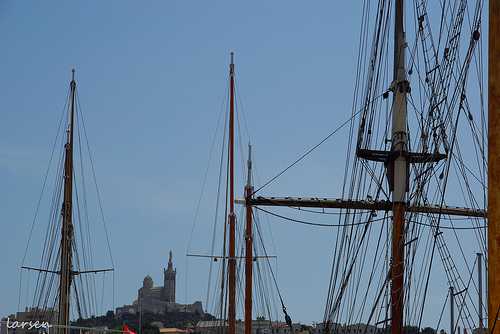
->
[391, 0, 408, 334]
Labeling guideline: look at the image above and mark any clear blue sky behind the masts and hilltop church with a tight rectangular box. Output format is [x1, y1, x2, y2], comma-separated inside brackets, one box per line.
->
[0, 0, 488, 324]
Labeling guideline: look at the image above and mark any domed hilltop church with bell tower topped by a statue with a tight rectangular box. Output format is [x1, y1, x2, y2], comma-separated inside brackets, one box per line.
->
[116, 251, 204, 316]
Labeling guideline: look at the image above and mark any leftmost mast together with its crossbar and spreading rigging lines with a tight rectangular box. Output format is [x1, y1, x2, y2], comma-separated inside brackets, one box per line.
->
[20, 69, 113, 334]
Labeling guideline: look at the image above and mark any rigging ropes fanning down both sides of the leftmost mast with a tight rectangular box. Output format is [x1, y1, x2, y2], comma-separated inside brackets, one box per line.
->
[18, 80, 114, 317]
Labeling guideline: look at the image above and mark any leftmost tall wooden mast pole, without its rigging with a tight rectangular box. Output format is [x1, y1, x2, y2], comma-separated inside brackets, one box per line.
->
[58, 69, 76, 334]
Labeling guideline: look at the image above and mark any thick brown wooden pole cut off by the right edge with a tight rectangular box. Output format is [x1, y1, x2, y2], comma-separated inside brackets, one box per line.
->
[488, 0, 500, 334]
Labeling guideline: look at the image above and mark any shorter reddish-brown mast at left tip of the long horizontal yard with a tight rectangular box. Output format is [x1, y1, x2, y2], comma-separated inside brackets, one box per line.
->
[245, 145, 253, 334]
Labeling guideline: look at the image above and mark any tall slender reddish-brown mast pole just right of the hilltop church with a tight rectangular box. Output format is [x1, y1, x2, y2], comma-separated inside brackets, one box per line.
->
[228, 51, 236, 334]
